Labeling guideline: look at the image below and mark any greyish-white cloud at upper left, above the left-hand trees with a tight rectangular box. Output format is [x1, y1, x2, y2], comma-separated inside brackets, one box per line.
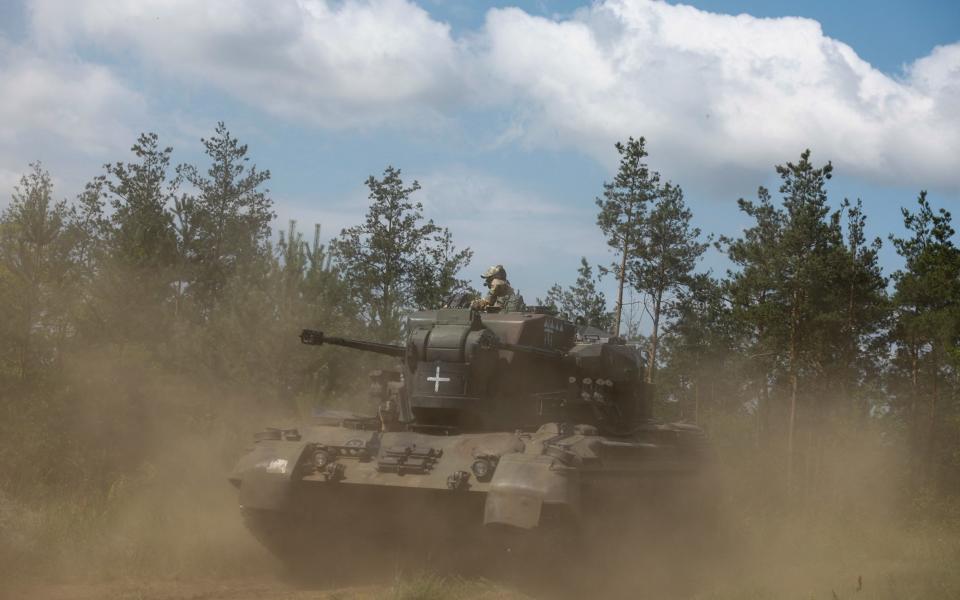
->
[32, 0, 462, 128]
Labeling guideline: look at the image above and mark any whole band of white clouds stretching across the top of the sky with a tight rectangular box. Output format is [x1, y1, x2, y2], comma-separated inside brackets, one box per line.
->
[13, 0, 960, 189]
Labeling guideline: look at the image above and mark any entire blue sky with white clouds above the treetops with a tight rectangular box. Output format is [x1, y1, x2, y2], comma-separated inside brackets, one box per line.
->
[0, 0, 960, 324]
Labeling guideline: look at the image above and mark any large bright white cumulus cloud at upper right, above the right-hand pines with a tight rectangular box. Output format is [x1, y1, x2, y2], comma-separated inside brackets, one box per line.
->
[479, 0, 960, 187]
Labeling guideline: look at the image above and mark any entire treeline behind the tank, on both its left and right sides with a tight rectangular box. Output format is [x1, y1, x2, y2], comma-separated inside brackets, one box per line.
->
[0, 123, 960, 506]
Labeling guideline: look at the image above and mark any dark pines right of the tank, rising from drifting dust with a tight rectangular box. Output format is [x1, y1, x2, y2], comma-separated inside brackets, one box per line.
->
[560, 138, 960, 496]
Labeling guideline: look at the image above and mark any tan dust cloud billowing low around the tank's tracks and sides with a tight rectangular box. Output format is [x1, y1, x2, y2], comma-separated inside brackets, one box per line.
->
[0, 366, 960, 600]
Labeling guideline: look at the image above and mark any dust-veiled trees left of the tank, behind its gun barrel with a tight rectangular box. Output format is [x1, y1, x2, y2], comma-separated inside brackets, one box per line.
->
[0, 123, 470, 501]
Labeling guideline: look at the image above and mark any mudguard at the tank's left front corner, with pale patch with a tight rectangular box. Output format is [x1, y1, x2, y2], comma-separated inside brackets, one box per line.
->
[230, 441, 307, 510]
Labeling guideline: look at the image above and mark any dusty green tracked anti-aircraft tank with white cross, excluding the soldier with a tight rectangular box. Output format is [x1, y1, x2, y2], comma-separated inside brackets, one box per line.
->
[231, 309, 706, 576]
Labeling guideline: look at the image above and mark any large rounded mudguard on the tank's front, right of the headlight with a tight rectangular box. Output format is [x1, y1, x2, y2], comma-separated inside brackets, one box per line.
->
[483, 453, 580, 529]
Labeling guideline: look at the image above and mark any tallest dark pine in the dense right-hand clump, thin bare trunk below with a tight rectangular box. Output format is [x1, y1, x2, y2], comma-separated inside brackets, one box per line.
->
[724, 150, 843, 491]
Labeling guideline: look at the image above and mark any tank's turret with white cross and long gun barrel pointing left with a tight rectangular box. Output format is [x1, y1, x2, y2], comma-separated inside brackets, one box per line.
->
[300, 309, 649, 431]
